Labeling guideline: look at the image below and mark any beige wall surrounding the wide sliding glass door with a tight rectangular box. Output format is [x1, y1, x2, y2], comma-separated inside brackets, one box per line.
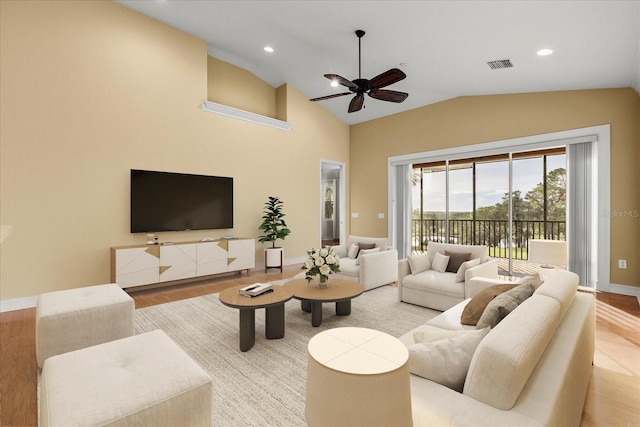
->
[350, 88, 640, 286]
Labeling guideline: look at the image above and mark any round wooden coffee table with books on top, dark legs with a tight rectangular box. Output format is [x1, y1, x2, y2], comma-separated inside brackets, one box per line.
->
[219, 285, 293, 351]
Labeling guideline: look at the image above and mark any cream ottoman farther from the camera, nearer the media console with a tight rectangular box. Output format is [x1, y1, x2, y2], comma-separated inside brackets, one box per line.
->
[36, 284, 135, 368]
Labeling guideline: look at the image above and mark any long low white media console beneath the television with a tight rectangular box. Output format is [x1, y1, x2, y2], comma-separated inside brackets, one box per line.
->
[111, 238, 256, 288]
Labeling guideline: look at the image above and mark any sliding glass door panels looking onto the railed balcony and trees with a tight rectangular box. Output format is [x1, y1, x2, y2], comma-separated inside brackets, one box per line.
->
[411, 147, 566, 275]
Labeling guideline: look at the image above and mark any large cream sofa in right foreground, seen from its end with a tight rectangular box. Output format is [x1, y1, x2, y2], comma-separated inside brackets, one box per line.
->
[400, 271, 595, 427]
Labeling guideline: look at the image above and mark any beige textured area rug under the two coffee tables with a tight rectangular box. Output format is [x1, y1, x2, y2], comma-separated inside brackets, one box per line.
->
[136, 286, 438, 427]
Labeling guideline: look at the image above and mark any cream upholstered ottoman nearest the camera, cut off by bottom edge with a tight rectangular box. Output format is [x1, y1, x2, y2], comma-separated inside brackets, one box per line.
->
[39, 330, 213, 427]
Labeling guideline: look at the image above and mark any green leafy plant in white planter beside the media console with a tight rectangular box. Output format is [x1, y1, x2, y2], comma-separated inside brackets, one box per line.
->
[258, 196, 291, 271]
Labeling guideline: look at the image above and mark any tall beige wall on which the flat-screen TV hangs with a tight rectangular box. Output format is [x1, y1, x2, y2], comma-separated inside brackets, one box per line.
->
[0, 0, 349, 300]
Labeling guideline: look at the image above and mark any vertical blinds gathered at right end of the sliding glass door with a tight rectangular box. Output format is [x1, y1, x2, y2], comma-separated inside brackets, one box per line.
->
[567, 142, 598, 288]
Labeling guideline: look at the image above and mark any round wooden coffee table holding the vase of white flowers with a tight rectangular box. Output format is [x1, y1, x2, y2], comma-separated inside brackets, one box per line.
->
[284, 279, 364, 327]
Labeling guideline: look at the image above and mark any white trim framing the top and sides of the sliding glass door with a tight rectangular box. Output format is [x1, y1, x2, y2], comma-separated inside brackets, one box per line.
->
[387, 124, 620, 292]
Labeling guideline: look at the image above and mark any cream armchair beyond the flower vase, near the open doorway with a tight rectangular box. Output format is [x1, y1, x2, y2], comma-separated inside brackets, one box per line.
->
[332, 236, 398, 291]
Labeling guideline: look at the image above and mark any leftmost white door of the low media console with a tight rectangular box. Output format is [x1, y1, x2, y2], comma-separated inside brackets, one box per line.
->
[112, 246, 160, 288]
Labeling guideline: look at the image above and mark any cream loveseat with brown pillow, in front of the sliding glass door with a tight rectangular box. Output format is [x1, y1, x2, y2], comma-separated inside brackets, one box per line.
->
[398, 242, 498, 311]
